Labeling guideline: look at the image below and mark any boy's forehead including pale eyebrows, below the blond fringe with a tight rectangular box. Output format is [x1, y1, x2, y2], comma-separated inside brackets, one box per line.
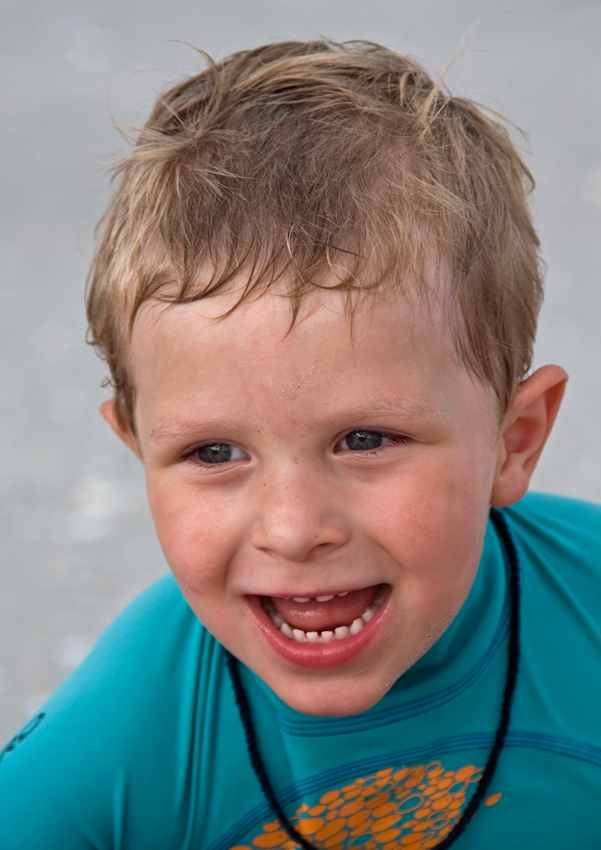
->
[131, 291, 490, 437]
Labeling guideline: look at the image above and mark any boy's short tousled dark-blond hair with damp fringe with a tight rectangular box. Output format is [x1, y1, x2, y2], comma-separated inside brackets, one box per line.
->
[87, 41, 543, 426]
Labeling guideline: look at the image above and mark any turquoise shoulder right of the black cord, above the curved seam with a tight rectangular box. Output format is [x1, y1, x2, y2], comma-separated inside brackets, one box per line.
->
[504, 493, 601, 744]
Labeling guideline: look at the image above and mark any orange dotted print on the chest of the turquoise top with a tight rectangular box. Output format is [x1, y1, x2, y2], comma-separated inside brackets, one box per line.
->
[231, 761, 501, 850]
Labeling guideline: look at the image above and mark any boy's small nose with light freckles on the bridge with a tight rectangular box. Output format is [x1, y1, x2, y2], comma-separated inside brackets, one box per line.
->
[251, 466, 350, 562]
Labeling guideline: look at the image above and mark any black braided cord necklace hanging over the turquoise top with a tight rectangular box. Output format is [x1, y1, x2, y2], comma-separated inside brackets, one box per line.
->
[226, 508, 521, 850]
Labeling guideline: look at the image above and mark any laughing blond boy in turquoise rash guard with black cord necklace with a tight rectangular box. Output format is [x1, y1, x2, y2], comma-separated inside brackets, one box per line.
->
[0, 42, 601, 850]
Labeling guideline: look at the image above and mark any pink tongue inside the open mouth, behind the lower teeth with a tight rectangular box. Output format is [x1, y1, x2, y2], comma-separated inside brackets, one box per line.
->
[270, 585, 379, 632]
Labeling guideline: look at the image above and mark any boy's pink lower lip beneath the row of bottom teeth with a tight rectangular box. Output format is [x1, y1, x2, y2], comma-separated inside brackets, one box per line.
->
[247, 587, 391, 668]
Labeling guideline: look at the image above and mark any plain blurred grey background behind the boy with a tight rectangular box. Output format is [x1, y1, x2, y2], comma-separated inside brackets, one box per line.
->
[0, 0, 601, 739]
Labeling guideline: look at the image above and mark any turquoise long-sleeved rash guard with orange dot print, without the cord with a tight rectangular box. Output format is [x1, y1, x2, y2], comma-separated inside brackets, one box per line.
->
[0, 486, 601, 850]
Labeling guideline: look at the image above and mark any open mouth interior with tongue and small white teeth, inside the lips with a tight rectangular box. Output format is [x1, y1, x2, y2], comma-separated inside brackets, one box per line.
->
[261, 584, 387, 644]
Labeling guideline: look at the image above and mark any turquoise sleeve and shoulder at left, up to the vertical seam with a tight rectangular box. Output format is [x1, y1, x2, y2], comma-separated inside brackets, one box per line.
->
[0, 576, 223, 850]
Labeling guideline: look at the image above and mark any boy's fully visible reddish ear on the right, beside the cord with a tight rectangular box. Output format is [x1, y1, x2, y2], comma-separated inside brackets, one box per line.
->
[490, 366, 568, 508]
